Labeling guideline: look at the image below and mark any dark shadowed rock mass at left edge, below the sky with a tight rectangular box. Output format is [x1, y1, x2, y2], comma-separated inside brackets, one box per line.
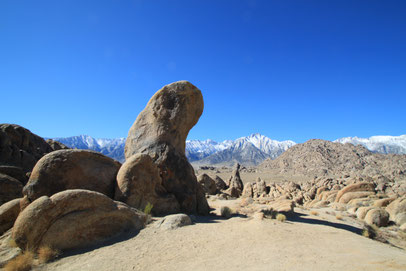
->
[0, 124, 59, 172]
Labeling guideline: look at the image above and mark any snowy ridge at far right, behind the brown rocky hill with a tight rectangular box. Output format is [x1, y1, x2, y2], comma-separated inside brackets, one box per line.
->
[334, 135, 406, 154]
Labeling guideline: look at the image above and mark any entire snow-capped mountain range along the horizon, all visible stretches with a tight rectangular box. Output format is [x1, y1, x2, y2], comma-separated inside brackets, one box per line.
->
[53, 134, 406, 166]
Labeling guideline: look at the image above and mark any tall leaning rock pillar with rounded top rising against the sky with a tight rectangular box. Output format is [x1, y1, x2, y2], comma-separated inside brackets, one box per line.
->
[125, 81, 209, 214]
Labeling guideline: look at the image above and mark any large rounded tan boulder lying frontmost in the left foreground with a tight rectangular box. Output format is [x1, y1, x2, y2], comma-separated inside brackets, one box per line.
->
[13, 190, 146, 250]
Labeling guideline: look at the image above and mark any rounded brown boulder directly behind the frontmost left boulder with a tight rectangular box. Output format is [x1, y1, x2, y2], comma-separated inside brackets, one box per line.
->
[23, 150, 120, 202]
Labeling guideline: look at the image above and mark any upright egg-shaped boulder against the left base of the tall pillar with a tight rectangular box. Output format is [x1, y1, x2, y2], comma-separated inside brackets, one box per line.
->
[114, 154, 180, 216]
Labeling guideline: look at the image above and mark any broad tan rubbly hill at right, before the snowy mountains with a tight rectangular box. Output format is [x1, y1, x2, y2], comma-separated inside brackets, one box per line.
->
[260, 139, 406, 180]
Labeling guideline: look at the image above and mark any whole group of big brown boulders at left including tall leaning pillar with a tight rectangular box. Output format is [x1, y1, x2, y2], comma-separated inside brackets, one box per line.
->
[0, 81, 209, 260]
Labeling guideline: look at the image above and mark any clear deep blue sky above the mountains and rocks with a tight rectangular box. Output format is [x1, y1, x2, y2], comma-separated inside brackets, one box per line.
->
[0, 0, 406, 142]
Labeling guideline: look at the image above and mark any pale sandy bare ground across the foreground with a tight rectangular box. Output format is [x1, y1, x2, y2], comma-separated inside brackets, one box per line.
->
[40, 199, 406, 271]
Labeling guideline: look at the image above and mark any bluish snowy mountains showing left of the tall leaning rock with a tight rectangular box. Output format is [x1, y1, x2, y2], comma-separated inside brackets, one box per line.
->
[53, 135, 125, 162]
